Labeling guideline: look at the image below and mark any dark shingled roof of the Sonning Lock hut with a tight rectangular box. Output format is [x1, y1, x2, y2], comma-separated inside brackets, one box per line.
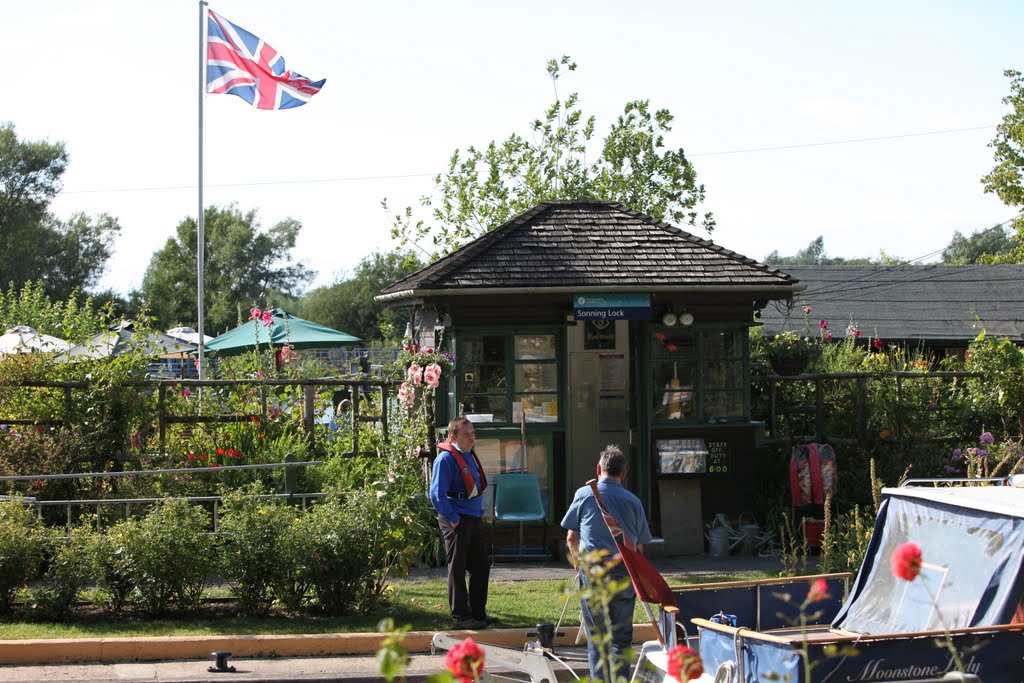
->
[379, 200, 798, 300]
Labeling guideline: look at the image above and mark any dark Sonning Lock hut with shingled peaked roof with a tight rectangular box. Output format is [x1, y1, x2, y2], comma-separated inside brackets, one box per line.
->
[378, 201, 802, 553]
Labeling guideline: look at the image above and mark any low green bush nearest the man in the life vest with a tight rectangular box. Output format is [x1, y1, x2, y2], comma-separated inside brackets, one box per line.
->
[299, 497, 375, 616]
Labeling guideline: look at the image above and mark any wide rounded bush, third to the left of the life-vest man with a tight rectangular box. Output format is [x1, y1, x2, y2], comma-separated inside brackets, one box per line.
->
[109, 499, 219, 614]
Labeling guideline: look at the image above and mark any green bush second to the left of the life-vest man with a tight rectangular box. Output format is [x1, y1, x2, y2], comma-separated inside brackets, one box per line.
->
[218, 486, 296, 616]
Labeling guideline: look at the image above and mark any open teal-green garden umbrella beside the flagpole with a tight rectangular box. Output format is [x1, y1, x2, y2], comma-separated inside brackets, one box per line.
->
[205, 308, 362, 355]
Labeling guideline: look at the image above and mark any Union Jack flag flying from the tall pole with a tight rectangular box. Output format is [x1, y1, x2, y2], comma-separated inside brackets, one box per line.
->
[206, 10, 327, 110]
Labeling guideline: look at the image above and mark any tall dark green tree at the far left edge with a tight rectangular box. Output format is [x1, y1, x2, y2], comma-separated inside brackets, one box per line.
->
[0, 123, 121, 299]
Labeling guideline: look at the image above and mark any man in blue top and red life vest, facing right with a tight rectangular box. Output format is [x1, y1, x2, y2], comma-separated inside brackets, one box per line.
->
[430, 418, 498, 629]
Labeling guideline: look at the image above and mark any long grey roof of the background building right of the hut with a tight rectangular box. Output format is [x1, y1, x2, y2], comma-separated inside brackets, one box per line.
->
[761, 265, 1024, 346]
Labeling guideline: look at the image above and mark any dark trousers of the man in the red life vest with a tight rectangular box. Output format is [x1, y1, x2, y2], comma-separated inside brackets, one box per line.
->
[437, 515, 490, 620]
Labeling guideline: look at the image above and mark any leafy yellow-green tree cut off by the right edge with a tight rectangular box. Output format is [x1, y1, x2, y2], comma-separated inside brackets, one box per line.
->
[981, 70, 1024, 263]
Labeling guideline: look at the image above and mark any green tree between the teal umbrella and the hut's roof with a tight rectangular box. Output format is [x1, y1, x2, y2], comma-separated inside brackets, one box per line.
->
[300, 252, 421, 341]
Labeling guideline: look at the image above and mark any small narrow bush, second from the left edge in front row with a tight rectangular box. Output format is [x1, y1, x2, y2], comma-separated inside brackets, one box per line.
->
[32, 526, 95, 621]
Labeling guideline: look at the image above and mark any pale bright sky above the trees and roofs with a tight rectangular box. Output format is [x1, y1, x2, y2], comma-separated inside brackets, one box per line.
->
[0, 0, 1024, 293]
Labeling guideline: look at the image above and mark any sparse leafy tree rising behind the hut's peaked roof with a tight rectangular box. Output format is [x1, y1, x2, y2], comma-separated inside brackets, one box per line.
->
[384, 56, 715, 257]
